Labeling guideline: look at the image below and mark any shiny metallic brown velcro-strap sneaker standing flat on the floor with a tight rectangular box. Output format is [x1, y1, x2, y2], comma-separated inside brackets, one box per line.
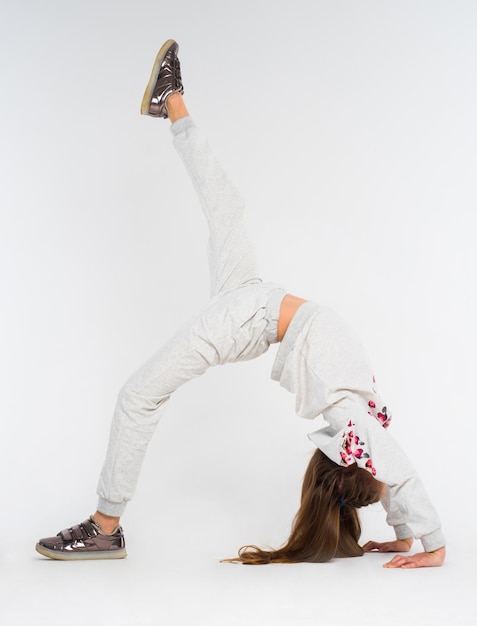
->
[36, 517, 127, 561]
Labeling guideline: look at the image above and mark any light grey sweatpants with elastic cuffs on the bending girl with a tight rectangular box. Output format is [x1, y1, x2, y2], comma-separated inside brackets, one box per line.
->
[98, 117, 286, 516]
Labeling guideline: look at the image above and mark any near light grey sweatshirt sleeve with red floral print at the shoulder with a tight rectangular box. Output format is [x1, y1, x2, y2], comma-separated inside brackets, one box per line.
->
[309, 412, 445, 552]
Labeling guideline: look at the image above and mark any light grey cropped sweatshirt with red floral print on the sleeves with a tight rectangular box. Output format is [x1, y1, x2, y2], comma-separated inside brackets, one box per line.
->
[272, 302, 445, 552]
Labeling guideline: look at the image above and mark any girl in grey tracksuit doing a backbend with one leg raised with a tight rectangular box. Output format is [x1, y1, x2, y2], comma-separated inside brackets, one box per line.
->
[36, 40, 445, 568]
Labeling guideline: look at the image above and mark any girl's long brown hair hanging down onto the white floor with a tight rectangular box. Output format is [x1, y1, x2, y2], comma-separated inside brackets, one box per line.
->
[227, 450, 383, 565]
